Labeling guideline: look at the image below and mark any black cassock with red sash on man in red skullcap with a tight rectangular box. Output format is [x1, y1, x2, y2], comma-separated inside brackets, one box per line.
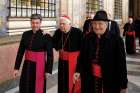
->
[53, 27, 82, 93]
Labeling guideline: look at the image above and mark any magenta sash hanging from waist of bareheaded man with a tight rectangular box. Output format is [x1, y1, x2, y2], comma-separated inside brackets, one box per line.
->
[25, 50, 46, 93]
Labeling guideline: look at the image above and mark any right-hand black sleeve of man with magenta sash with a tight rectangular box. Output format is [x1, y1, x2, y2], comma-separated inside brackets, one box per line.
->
[45, 35, 53, 74]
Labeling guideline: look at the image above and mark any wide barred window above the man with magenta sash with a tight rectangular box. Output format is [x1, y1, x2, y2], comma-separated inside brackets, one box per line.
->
[8, 0, 56, 18]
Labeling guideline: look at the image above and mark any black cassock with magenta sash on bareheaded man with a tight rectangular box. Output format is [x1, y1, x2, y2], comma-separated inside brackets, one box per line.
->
[14, 30, 53, 93]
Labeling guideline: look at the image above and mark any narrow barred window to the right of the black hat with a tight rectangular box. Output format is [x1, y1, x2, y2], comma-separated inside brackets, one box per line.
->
[114, 0, 122, 19]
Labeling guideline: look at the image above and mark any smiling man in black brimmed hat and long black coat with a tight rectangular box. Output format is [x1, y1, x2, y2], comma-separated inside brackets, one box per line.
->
[74, 11, 128, 93]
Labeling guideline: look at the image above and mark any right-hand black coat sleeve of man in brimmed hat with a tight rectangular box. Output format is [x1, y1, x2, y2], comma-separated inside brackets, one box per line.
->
[117, 37, 128, 89]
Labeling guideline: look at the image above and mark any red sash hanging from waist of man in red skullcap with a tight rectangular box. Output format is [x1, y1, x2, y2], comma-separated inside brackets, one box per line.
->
[59, 51, 81, 93]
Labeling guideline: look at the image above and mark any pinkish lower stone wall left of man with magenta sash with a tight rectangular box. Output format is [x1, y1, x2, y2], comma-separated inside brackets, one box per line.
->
[0, 43, 18, 83]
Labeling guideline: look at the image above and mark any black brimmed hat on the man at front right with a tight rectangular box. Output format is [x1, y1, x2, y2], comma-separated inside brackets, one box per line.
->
[93, 10, 110, 21]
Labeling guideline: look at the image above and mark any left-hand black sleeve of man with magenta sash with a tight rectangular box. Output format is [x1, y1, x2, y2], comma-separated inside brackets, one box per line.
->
[14, 33, 25, 70]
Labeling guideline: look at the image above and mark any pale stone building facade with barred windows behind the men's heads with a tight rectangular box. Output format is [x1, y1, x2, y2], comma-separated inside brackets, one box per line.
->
[0, 0, 135, 35]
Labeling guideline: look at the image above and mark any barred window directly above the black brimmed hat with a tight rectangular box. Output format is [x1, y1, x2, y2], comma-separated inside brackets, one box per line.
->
[86, 0, 103, 17]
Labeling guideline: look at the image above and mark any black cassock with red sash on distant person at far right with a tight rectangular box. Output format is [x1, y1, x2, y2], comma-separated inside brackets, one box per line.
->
[123, 23, 136, 54]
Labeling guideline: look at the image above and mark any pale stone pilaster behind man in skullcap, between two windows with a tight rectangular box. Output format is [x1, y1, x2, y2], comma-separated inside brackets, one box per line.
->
[60, 0, 86, 28]
